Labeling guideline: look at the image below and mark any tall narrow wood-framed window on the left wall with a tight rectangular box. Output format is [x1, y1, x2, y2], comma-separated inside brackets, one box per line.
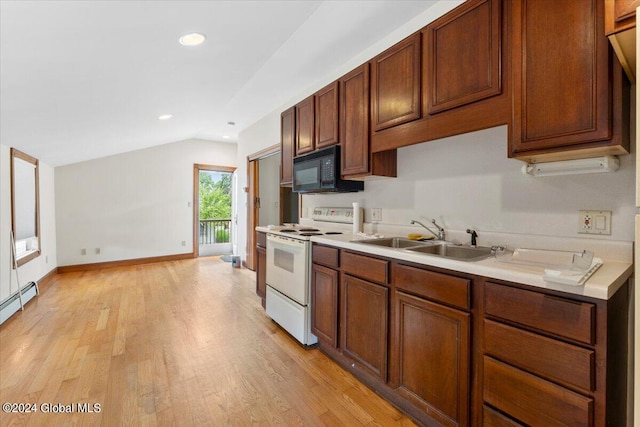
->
[11, 148, 40, 265]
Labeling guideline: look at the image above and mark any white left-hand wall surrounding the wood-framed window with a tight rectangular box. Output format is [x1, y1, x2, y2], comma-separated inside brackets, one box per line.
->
[0, 145, 58, 302]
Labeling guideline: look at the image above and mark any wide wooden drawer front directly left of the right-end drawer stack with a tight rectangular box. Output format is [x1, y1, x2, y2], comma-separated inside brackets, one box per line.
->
[392, 264, 471, 310]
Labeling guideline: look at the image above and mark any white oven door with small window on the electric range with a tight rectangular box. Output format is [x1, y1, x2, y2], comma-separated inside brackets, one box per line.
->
[266, 234, 311, 305]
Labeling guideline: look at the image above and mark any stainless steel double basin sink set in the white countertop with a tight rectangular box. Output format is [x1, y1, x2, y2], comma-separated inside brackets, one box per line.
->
[353, 237, 492, 261]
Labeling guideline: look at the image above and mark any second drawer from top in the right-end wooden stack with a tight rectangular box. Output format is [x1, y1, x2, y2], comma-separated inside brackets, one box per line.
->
[484, 320, 595, 390]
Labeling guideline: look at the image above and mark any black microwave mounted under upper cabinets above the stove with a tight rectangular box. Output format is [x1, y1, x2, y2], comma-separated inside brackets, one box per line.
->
[293, 145, 364, 193]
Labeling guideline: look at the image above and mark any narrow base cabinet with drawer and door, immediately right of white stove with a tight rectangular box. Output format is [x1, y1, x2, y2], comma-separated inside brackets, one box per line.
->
[311, 244, 340, 348]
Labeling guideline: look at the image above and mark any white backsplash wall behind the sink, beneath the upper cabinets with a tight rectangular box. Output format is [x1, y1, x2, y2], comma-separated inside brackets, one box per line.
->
[302, 126, 636, 243]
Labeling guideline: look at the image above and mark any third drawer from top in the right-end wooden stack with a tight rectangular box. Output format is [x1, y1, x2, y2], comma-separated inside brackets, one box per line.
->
[483, 356, 593, 427]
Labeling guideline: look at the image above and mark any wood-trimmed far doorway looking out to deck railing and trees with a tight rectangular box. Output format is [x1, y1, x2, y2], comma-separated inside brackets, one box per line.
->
[193, 164, 235, 257]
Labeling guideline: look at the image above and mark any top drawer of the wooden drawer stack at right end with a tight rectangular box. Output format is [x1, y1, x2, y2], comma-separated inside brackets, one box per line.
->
[484, 283, 596, 344]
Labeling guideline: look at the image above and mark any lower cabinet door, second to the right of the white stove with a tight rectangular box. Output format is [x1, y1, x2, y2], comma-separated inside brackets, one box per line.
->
[340, 274, 389, 381]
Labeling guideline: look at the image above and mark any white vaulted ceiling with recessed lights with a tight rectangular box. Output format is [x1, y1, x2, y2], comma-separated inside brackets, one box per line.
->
[0, 0, 436, 166]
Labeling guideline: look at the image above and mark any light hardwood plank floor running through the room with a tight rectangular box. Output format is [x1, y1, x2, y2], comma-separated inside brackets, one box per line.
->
[0, 257, 414, 426]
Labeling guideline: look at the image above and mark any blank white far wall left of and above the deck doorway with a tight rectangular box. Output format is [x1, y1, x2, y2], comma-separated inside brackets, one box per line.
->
[55, 139, 237, 266]
